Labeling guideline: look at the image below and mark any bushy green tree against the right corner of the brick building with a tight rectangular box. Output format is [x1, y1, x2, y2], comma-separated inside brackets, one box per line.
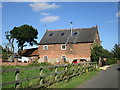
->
[91, 43, 103, 62]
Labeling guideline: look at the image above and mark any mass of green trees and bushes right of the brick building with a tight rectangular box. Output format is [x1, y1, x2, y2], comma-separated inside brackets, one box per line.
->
[91, 43, 117, 64]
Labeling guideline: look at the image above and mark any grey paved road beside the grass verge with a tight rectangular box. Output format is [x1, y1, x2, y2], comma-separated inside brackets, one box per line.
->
[77, 64, 120, 88]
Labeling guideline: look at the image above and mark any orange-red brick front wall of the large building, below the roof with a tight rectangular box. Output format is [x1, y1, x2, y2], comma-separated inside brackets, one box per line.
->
[38, 43, 91, 63]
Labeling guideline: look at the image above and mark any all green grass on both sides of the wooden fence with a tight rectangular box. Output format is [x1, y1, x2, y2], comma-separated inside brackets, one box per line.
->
[2, 64, 97, 88]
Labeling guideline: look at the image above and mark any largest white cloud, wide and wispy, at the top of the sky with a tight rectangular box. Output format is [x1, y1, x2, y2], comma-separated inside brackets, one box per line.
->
[30, 2, 59, 11]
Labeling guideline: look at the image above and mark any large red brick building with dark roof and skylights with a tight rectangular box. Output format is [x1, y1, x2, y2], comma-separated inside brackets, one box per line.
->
[38, 26, 100, 63]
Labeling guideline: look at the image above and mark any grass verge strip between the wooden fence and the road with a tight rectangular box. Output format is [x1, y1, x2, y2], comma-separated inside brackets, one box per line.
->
[48, 71, 98, 88]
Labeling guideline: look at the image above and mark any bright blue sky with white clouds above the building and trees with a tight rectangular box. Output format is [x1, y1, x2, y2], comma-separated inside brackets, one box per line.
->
[2, 2, 120, 50]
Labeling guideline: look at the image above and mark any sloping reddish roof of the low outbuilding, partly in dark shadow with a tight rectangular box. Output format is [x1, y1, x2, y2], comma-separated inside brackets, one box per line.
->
[22, 48, 38, 57]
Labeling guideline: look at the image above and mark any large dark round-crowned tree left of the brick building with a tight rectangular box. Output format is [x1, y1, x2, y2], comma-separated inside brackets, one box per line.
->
[10, 25, 38, 52]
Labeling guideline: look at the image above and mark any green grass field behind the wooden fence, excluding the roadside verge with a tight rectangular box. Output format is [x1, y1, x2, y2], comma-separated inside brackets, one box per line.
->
[2, 66, 63, 88]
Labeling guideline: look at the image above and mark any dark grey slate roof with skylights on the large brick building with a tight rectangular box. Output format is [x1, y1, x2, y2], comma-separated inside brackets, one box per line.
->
[39, 27, 98, 45]
